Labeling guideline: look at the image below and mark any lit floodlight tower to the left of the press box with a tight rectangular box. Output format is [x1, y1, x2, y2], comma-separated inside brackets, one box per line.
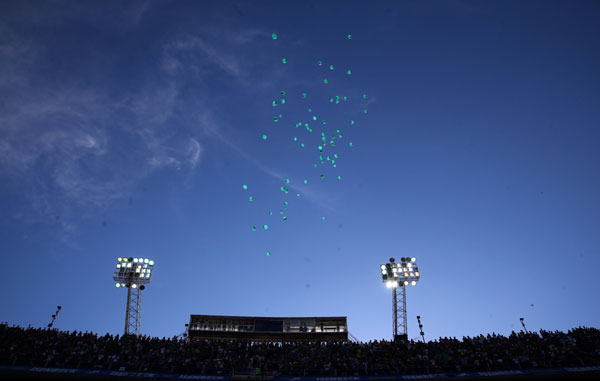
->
[113, 257, 154, 336]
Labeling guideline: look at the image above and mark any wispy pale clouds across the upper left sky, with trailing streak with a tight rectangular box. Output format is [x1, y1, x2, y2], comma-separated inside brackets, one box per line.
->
[0, 2, 284, 238]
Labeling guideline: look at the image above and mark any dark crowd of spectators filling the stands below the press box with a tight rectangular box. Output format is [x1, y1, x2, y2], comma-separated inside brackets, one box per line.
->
[0, 324, 600, 376]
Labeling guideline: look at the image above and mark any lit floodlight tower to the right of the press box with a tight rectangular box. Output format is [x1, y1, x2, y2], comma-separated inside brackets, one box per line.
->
[380, 257, 421, 340]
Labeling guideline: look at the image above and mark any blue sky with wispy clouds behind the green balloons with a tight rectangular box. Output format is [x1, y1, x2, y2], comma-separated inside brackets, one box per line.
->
[0, 0, 600, 341]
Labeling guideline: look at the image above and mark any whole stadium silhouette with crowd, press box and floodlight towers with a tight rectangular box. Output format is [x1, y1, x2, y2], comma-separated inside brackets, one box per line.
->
[0, 257, 600, 381]
